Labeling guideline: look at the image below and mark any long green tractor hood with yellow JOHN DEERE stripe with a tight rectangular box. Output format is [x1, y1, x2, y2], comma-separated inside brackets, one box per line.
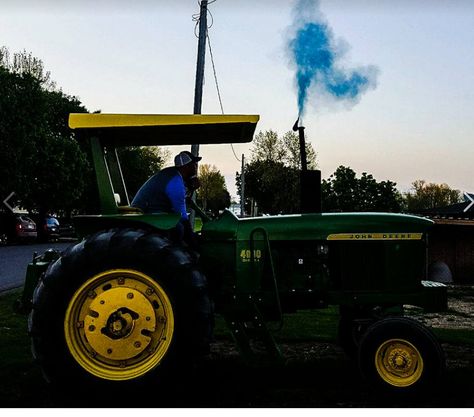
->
[202, 211, 433, 241]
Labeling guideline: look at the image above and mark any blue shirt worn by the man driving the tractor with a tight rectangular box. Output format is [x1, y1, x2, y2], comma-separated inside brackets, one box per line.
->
[131, 167, 188, 220]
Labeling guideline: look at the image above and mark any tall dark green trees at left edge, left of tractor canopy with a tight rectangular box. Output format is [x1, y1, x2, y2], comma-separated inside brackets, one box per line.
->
[0, 48, 90, 213]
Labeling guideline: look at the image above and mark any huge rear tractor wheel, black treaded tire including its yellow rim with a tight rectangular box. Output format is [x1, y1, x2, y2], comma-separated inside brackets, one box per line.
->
[29, 229, 211, 383]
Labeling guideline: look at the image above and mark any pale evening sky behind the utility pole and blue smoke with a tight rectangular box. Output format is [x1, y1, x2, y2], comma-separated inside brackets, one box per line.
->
[0, 0, 474, 196]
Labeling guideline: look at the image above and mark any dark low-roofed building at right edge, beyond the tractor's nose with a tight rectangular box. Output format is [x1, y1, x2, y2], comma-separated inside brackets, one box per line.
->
[417, 193, 474, 284]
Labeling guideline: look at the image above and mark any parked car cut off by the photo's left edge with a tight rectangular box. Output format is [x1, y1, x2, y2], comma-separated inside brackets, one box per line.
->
[0, 212, 38, 245]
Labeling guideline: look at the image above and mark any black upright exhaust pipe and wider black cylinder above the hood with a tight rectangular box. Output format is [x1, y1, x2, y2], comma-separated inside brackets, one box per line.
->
[293, 117, 321, 213]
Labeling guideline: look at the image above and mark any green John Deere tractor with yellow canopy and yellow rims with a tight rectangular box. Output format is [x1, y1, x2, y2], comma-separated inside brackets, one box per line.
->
[23, 114, 447, 392]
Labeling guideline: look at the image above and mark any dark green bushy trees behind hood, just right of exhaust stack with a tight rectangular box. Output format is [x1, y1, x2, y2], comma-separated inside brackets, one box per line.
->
[321, 166, 402, 212]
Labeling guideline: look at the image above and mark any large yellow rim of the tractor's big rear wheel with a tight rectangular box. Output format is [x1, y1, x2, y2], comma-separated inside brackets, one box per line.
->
[64, 269, 174, 381]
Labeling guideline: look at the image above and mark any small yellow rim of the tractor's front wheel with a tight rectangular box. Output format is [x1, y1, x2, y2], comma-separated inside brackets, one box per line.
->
[375, 339, 423, 387]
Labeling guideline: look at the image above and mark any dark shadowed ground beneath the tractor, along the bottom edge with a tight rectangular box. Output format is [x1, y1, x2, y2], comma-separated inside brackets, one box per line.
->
[4, 341, 474, 408]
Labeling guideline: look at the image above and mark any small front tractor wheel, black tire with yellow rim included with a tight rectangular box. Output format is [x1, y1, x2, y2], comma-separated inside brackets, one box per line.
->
[359, 317, 445, 392]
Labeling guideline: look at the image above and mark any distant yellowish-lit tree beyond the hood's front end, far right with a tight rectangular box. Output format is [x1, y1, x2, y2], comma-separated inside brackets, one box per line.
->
[405, 180, 462, 212]
